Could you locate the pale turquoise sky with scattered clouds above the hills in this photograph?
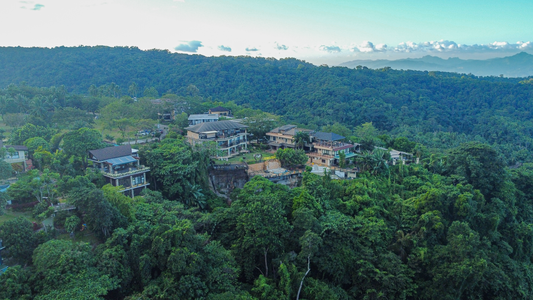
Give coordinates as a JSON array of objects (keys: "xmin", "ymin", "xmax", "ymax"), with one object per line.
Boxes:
[{"xmin": 0, "ymin": 0, "xmax": 533, "ymax": 65}]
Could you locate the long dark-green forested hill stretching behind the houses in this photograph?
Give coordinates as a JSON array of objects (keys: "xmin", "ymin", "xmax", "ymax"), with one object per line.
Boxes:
[{"xmin": 0, "ymin": 47, "xmax": 533, "ymax": 163}]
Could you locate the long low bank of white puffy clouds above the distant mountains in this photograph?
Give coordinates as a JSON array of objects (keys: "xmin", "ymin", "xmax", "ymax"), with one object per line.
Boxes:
[{"xmin": 349, "ymin": 40, "xmax": 533, "ymax": 53}]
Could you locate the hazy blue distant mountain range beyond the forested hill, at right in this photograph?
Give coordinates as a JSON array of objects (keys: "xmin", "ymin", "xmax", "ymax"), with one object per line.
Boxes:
[{"xmin": 340, "ymin": 52, "xmax": 533, "ymax": 77}]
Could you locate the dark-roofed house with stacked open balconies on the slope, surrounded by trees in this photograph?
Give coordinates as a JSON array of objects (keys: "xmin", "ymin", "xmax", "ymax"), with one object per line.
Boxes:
[{"xmin": 89, "ymin": 145, "xmax": 150, "ymax": 197}]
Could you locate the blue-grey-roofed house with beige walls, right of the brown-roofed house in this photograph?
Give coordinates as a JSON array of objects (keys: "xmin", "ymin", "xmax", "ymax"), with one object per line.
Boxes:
[{"xmin": 307, "ymin": 132, "xmax": 360, "ymax": 167}]
